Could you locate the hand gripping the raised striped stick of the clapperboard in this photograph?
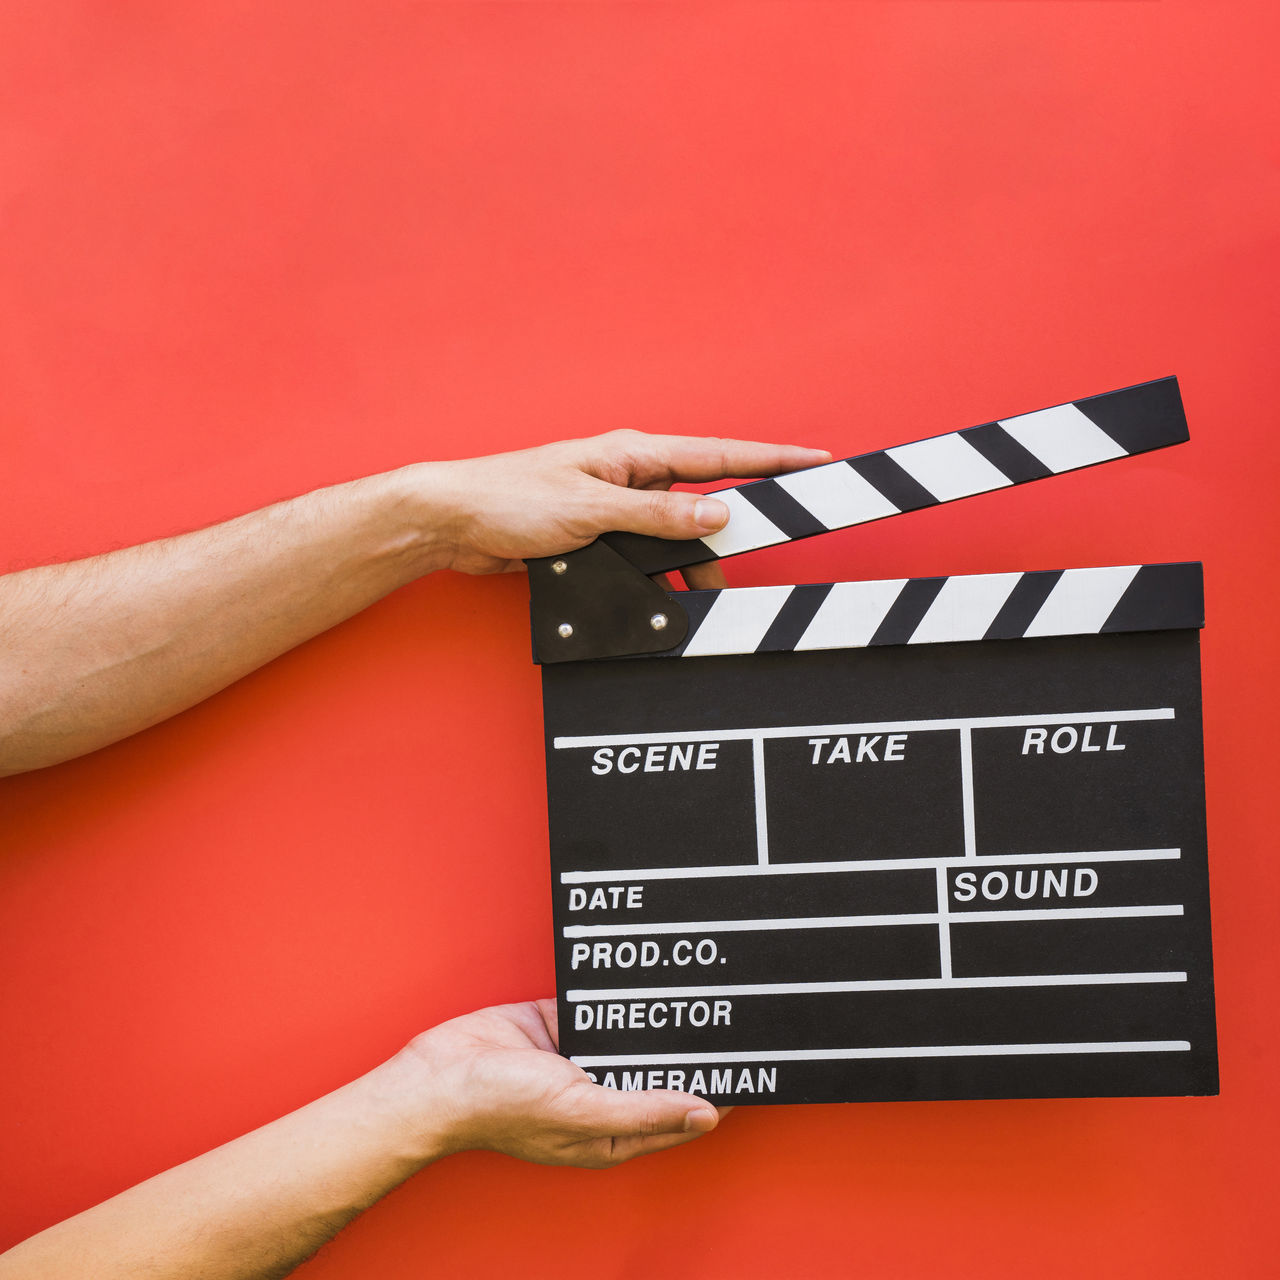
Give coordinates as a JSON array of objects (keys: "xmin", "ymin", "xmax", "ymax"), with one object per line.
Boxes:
[{"xmin": 410, "ymin": 431, "xmax": 831, "ymax": 585}]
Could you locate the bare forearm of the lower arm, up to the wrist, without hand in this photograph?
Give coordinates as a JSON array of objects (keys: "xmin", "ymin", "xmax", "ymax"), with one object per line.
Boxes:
[{"xmin": 0, "ymin": 1057, "xmax": 442, "ymax": 1280}]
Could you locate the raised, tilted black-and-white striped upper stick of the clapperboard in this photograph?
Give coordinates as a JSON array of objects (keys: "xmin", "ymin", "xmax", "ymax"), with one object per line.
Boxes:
[{"xmin": 603, "ymin": 378, "xmax": 1188, "ymax": 573}]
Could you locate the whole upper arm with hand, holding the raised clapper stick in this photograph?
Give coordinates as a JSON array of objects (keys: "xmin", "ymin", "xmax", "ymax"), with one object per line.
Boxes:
[{"xmin": 0, "ymin": 431, "xmax": 828, "ymax": 776}]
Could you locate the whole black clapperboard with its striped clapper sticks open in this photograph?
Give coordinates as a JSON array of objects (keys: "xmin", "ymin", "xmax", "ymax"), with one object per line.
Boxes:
[{"xmin": 530, "ymin": 378, "xmax": 1217, "ymax": 1103}]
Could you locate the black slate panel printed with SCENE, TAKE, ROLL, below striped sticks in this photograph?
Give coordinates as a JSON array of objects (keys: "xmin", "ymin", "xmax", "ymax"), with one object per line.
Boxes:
[{"xmin": 543, "ymin": 628, "xmax": 1217, "ymax": 1105}]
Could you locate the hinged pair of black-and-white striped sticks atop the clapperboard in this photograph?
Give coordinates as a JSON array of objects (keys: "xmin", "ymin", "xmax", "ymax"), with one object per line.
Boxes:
[{"xmin": 529, "ymin": 378, "xmax": 1187, "ymax": 663}]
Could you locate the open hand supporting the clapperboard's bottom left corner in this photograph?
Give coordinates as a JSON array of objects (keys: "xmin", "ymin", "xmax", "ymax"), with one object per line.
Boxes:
[{"xmin": 394, "ymin": 1000, "xmax": 728, "ymax": 1169}]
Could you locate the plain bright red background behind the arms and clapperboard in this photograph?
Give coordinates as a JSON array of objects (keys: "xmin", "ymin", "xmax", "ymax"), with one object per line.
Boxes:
[{"xmin": 0, "ymin": 0, "xmax": 1280, "ymax": 1280}]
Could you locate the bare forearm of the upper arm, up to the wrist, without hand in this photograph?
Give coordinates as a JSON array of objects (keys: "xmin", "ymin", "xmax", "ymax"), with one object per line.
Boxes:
[{"xmin": 0, "ymin": 467, "xmax": 448, "ymax": 774}]
